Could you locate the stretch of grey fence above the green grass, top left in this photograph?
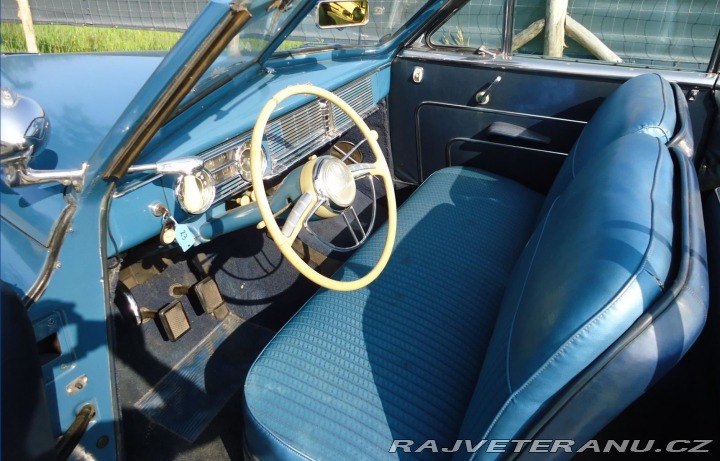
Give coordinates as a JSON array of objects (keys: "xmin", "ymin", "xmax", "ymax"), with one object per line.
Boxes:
[{"xmin": 0, "ymin": 0, "xmax": 207, "ymax": 31}]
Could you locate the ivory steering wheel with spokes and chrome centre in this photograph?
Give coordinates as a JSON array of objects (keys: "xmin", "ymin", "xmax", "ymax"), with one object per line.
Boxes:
[{"xmin": 250, "ymin": 84, "xmax": 397, "ymax": 291}]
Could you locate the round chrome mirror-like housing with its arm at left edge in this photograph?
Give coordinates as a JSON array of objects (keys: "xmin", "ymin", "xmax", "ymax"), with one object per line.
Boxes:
[{"xmin": 0, "ymin": 87, "xmax": 87, "ymax": 190}]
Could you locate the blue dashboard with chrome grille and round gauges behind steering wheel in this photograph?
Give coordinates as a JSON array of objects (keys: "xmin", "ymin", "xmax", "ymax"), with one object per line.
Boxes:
[{"xmin": 108, "ymin": 63, "xmax": 389, "ymax": 254}]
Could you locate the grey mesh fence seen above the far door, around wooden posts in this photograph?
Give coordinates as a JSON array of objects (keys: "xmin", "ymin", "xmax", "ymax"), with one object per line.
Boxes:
[{"xmin": 431, "ymin": 0, "xmax": 720, "ymax": 70}]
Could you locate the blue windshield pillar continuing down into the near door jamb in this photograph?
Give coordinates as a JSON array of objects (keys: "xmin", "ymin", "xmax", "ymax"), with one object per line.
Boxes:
[{"xmin": 11, "ymin": 1, "xmax": 243, "ymax": 460}]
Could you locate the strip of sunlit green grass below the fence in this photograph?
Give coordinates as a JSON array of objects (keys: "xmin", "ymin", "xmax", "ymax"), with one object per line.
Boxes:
[{"xmin": 0, "ymin": 23, "xmax": 182, "ymax": 53}]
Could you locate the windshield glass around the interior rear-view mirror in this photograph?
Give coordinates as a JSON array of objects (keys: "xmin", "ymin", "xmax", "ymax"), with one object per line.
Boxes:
[{"xmin": 277, "ymin": 0, "xmax": 428, "ymax": 52}]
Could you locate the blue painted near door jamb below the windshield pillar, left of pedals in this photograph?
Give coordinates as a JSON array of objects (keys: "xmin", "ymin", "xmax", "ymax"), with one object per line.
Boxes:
[{"xmin": 29, "ymin": 201, "xmax": 118, "ymax": 459}]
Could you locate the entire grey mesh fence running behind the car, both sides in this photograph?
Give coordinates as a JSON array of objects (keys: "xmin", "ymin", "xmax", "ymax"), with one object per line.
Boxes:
[{"xmin": 0, "ymin": 0, "xmax": 720, "ymax": 70}]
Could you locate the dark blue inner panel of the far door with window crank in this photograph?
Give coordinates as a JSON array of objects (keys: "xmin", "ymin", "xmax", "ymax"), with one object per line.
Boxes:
[{"xmin": 389, "ymin": 51, "xmax": 715, "ymax": 186}]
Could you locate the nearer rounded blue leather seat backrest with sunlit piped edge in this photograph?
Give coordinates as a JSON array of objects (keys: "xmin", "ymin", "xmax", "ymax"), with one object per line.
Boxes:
[{"xmin": 456, "ymin": 134, "xmax": 674, "ymax": 459}]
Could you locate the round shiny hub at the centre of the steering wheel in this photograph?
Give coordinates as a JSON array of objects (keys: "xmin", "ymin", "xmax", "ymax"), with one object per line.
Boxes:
[{"xmin": 313, "ymin": 156, "xmax": 357, "ymax": 212}]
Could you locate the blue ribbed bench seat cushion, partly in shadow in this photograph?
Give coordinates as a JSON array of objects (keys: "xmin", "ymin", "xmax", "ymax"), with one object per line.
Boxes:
[{"xmin": 245, "ymin": 168, "xmax": 543, "ymax": 460}]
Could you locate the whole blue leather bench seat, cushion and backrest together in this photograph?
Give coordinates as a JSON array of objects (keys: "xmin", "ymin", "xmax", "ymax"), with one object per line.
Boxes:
[{"xmin": 245, "ymin": 75, "xmax": 707, "ymax": 460}]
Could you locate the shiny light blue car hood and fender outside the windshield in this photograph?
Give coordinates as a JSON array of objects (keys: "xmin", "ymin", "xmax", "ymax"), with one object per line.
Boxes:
[{"xmin": 0, "ymin": 53, "xmax": 164, "ymax": 246}]
